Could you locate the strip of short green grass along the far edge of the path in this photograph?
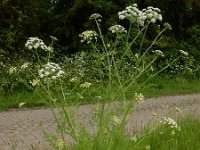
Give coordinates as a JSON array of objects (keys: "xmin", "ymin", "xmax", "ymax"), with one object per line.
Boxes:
[{"xmin": 0, "ymin": 78, "xmax": 200, "ymax": 110}]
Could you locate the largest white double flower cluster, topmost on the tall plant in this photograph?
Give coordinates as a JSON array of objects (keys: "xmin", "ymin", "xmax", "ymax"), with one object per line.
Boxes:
[{"xmin": 118, "ymin": 4, "xmax": 162, "ymax": 26}]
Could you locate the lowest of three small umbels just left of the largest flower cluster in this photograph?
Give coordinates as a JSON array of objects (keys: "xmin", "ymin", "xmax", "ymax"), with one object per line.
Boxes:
[{"xmin": 79, "ymin": 30, "xmax": 98, "ymax": 44}]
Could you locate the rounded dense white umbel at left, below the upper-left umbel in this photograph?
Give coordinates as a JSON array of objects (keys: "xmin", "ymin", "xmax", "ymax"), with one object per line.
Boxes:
[{"xmin": 38, "ymin": 62, "xmax": 64, "ymax": 80}]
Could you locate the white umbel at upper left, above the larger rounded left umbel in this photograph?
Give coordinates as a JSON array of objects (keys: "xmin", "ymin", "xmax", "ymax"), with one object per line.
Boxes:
[{"xmin": 25, "ymin": 37, "xmax": 47, "ymax": 51}]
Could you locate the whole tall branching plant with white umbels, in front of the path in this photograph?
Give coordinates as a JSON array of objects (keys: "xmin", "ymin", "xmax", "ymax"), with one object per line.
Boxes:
[{"xmin": 19, "ymin": 4, "xmax": 191, "ymax": 149}]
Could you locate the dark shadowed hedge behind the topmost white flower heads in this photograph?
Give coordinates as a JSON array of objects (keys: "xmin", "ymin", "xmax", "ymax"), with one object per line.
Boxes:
[{"xmin": 0, "ymin": 0, "xmax": 200, "ymax": 59}]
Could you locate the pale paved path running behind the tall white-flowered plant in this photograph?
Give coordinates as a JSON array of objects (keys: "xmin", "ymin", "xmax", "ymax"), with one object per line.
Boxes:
[{"xmin": 0, "ymin": 94, "xmax": 200, "ymax": 150}]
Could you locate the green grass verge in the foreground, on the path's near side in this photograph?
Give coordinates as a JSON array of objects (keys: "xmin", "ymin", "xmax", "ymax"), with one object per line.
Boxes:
[{"xmin": 48, "ymin": 114, "xmax": 200, "ymax": 150}]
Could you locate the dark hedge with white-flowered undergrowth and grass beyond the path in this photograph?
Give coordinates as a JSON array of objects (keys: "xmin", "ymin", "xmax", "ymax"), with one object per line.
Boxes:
[{"xmin": 0, "ymin": 0, "xmax": 200, "ymax": 108}]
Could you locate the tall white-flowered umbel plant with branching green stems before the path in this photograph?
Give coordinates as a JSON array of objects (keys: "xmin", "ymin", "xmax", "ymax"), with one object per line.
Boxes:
[{"xmin": 21, "ymin": 4, "xmax": 189, "ymax": 150}]
